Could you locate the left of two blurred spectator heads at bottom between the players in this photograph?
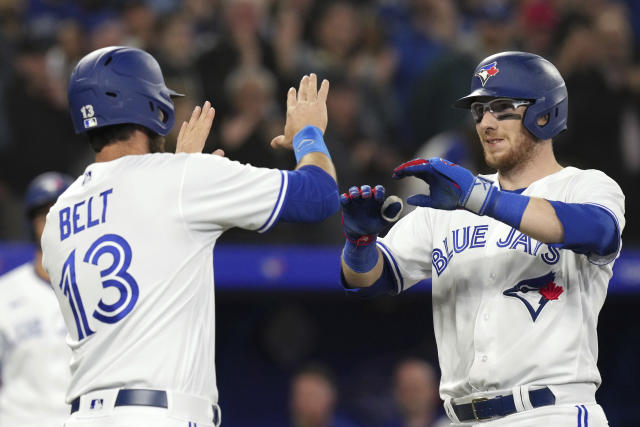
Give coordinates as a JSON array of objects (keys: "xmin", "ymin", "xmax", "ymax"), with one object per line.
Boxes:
[{"xmin": 289, "ymin": 365, "xmax": 355, "ymax": 427}]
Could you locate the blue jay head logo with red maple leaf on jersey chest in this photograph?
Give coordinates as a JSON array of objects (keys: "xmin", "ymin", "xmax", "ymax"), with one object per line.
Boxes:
[{"xmin": 503, "ymin": 271, "xmax": 564, "ymax": 322}]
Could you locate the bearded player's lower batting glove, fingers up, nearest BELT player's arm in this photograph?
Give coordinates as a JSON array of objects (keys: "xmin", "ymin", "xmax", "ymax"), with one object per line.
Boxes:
[{"xmin": 340, "ymin": 185, "xmax": 402, "ymax": 246}]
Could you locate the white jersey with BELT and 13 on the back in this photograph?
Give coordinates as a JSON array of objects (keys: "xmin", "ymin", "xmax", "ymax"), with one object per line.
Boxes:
[{"xmin": 42, "ymin": 153, "xmax": 287, "ymax": 403}]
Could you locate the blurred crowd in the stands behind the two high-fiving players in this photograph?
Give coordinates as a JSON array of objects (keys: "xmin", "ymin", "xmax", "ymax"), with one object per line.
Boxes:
[{"xmin": 0, "ymin": 0, "xmax": 640, "ymax": 244}]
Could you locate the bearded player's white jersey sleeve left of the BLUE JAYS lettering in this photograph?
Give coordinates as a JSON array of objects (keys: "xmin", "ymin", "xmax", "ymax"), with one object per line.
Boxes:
[{"xmin": 377, "ymin": 208, "xmax": 433, "ymax": 294}]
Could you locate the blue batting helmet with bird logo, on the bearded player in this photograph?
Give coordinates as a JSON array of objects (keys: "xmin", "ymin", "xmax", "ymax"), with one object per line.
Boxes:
[{"xmin": 454, "ymin": 52, "xmax": 569, "ymax": 139}]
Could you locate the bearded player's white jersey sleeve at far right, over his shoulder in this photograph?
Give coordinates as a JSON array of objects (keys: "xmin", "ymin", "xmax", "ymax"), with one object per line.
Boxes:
[{"xmin": 565, "ymin": 169, "xmax": 625, "ymax": 265}]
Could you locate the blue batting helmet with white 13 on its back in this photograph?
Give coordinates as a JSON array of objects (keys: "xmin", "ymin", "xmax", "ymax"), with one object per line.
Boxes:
[{"xmin": 68, "ymin": 46, "xmax": 182, "ymax": 135}]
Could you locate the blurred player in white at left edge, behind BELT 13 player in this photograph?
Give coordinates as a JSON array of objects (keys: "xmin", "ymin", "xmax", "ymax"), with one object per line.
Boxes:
[{"xmin": 0, "ymin": 172, "xmax": 72, "ymax": 427}]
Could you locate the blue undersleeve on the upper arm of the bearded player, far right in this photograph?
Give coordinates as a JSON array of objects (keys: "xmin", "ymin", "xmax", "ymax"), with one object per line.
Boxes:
[{"xmin": 549, "ymin": 200, "xmax": 620, "ymax": 255}]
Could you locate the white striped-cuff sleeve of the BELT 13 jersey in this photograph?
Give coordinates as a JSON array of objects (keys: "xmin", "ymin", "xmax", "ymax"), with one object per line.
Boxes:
[{"xmin": 179, "ymin": 154, "xmax": 287, "ymax": 232}]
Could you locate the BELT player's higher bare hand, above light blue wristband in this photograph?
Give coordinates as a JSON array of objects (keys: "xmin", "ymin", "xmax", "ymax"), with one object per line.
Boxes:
[{"xmin": 271, "ymin": 73, "xmax": 329, "ymax": 150}]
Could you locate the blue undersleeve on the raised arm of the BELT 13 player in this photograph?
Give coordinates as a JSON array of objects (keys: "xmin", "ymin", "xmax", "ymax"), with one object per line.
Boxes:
[{"xmin": 279, "ymin": 165, "xmax": 340, "ymax": 222}]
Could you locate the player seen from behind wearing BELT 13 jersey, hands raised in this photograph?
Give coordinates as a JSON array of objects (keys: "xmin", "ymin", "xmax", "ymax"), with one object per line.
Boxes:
[{"xmin": 42, "ymin": 47, "xmax": 339, "ymax": 427}]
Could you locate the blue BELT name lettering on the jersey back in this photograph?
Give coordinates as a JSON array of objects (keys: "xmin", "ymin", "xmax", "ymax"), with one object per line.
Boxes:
[{"xmin": 59, "ymin": 188, "xmax": 113, "ymax": 241}]
